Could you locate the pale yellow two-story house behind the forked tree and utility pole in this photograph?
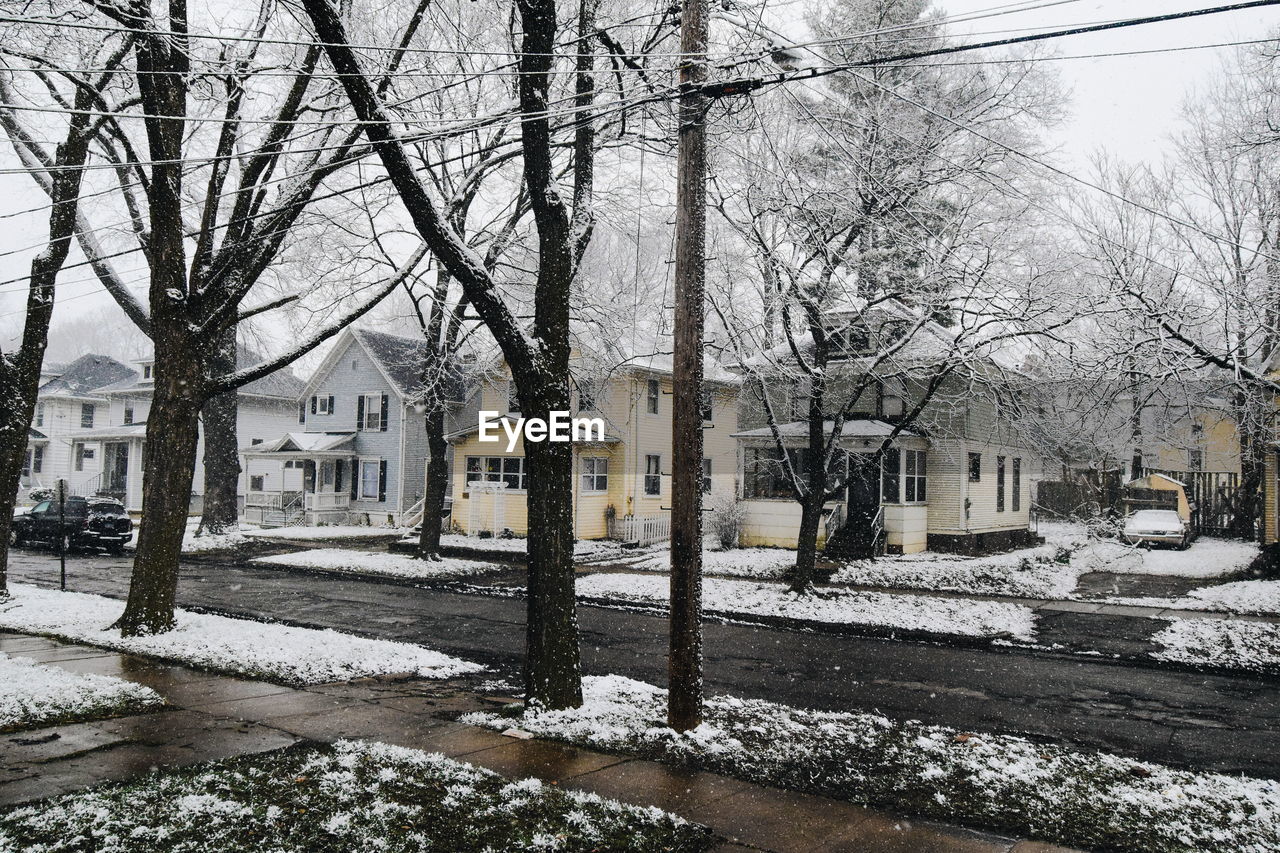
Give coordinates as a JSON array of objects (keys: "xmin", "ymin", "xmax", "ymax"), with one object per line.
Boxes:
[{"xmin": 449, "ymin": 356, "xmax": 739, "ymax": 543}]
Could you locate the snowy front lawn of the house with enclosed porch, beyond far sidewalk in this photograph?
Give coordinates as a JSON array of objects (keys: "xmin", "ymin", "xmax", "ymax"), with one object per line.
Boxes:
[{"xmin": 831, "ymin": 544, "xmax": 1080, "ymax": 598}]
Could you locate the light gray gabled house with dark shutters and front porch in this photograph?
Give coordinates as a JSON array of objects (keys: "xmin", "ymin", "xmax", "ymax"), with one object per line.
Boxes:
[{"xmin": 241, "ymin": 329, "xmax": 460, "ymax": 526}]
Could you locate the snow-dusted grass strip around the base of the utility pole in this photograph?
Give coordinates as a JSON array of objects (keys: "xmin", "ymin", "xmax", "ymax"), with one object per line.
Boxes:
[{"xmin": 462, "ymin": 676, "xmax": 1280, "ymax": 853}]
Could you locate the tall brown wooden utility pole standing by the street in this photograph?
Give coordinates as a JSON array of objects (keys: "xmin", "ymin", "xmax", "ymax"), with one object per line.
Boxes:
[{"xmin": 667, "ymin": 0, "xmax": 708, "ymax": 731}]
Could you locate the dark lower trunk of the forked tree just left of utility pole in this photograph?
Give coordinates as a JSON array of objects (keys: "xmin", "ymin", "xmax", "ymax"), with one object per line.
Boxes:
[{"xmin": 525, "ymin": 394, "xmax": 582, "ymax": 710}]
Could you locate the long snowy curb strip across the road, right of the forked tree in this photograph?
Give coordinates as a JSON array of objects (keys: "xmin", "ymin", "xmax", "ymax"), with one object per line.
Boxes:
[{"xmin": 577, "ymin": 574, "xmax": 1036, "ymax": 640}]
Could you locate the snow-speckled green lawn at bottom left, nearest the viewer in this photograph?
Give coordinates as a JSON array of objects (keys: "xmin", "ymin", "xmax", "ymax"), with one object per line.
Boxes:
[{"xmin": 0, "ymin": 740, "xmax": 710, "ymax": 853}]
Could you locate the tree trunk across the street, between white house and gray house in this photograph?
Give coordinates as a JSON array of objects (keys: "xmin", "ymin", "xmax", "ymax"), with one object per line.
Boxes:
[{"xmin": 200, "ymin": 325, "xmax": 241, "ymax": 535}]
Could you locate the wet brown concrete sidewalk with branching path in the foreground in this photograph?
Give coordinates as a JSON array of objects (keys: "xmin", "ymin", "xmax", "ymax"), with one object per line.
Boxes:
[{"xmin": 0, "ymin": 633, "xmax": 1080, "ymax": 853}]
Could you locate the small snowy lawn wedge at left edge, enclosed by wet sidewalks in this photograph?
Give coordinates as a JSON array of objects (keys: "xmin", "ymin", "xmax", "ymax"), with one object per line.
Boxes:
[{"xmin": 0, "ymin": 653, "xmax": 163, "ymax": 731}]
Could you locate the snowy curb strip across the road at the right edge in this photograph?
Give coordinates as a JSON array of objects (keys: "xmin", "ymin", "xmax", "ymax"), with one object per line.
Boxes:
[{"xmin": 1151, "ymin": 619, "xmax": 1280, "ymax": 672}]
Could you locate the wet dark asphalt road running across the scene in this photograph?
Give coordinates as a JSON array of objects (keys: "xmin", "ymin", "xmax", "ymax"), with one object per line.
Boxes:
[{"xmin": 10, "ymin": 549, "xmax": 1280, "ymax": 779}]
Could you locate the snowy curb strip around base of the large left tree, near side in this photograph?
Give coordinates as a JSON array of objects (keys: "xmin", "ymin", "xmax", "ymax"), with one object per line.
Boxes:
[{"xmin": 0, "ymin": 584, "xmax": 484, "ymax": 684}]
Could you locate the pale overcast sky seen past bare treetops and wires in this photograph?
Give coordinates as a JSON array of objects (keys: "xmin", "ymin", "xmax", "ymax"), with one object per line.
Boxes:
[{"xmin": 0, "ymin": 0, "xmax": 1280, "ymax": 342}]
